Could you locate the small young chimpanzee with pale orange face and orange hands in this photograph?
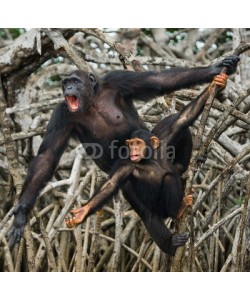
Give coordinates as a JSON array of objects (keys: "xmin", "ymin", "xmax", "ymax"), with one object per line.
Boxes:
[{"xmin": 66, "ymin": 74, "xmax": 228, "ymax": 255}]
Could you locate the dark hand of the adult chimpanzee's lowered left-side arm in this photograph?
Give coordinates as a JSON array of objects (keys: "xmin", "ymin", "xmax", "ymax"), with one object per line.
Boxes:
[{"xmin": 7, "ymin": 204, "xmax": 28, "ymax": 248}]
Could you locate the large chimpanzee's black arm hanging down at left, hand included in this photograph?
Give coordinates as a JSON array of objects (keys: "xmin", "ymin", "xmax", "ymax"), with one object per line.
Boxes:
[{"xmin": 8, "ymin": 105, "xmax": 71, "ymax": 247}]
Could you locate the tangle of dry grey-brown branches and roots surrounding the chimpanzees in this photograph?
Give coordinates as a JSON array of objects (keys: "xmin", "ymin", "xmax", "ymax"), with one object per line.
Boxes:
[{"xmin": 0, "ymin": 29, "xmax": 250, "ymax": 272}]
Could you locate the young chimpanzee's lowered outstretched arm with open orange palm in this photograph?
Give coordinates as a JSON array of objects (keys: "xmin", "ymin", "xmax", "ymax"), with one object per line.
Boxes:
[{"xmin": 65, "ymin": 164, "xmax": 133, "ymax": 228}]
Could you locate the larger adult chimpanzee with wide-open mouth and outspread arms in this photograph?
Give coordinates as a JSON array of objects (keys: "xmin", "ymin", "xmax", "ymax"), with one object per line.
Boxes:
[{"xmin": 9, "ymin": 56, "xmax": 239, "ymax": 246}]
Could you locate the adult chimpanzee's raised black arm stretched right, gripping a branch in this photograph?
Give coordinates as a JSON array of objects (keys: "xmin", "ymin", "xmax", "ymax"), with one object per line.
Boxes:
[{"xmin": 103, "ymin": 56, "xmax": 239, "ymax": 100}]
